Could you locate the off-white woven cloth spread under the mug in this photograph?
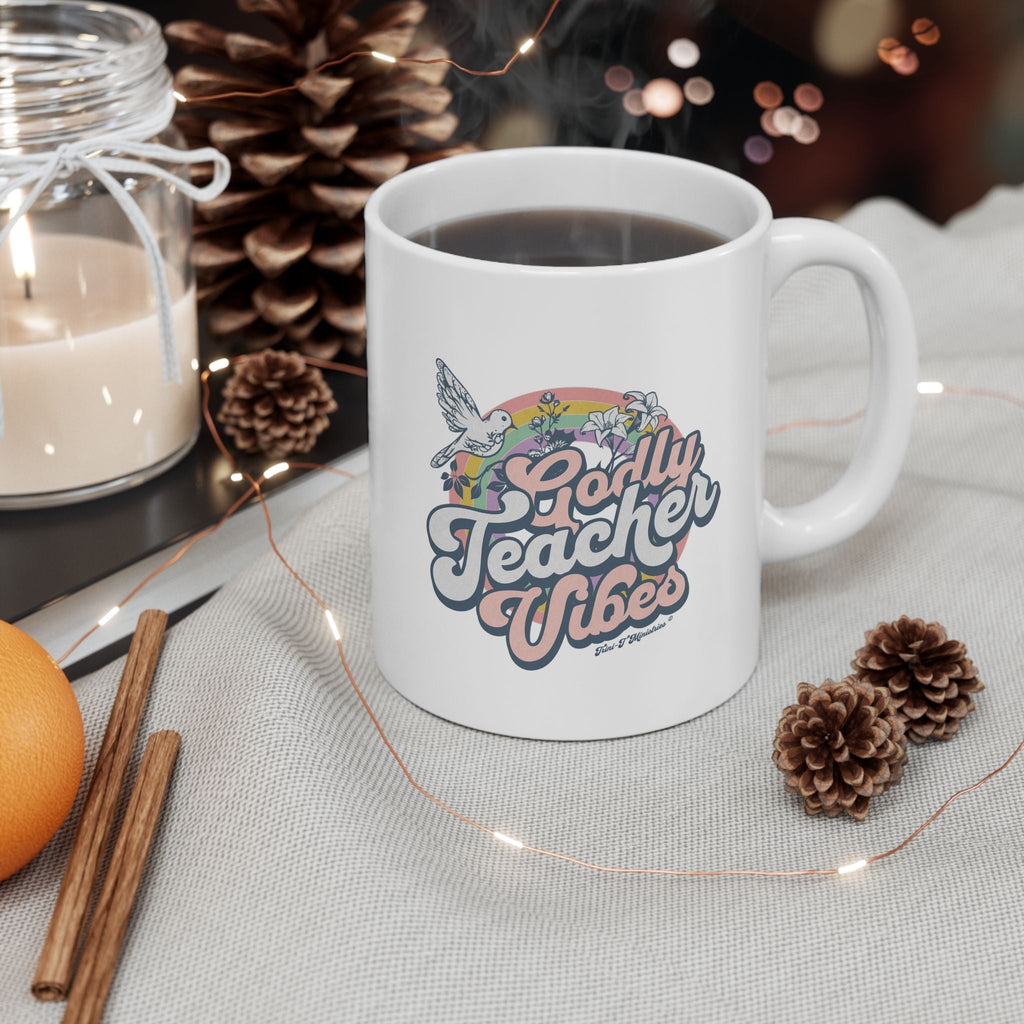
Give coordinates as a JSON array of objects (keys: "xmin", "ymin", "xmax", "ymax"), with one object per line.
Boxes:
[{"xmin": 0, "ymin": 189, "xmax": 1024, "ymax": 1024}]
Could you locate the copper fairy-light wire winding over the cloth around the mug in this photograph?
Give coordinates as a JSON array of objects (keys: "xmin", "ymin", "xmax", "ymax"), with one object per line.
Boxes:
[{"xmin": 57, "ymin": 356, "xmax": 1024, "ymax": 879}]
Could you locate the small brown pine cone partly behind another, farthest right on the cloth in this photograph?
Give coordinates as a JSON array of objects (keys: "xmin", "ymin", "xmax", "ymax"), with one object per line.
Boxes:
[{"xmin": 852, "ymin": 615, "xmax": 985, "ymax": 743}]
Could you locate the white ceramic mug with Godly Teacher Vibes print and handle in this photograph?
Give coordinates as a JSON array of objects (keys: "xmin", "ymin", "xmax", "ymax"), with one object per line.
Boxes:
[{"xmin": 366, "ymin": 147, "xmax": 916, "ymax": 739}]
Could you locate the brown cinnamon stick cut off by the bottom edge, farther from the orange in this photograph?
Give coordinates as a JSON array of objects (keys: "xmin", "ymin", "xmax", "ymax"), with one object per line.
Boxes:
[{"xmin": 63, "ymin": 732, "xmax": 181, "ymax": 1024}]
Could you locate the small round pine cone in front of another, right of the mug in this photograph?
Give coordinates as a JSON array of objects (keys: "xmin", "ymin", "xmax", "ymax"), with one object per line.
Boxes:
[{"xmin": 772, "ymin": 676, "xmax": 906, "ymax": 821}]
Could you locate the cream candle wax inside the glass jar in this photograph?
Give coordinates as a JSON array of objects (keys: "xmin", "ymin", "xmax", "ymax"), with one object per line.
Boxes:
[{"xmin": 0, "ymin": 234, "xmax": 199, "ymax": 499}]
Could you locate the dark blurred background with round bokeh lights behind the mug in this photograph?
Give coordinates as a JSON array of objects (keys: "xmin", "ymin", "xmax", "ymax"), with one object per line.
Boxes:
[{"xmin": 146, "ymin": 0, "xmax": 1024, "ymax": 221}]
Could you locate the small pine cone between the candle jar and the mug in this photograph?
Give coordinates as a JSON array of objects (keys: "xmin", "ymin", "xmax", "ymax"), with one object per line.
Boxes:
[{"xmin": 217, "ymin": 349, "xmax": 338, "ymax": 458}]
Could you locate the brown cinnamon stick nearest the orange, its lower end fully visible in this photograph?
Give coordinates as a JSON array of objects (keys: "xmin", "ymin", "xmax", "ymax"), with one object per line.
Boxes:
[{"xmin": 32, "ymin": 610, "xmax": 167, "ymax": 1002}]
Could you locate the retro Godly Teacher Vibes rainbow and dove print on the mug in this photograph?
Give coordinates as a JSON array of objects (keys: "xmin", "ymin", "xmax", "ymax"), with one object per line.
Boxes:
[{"xmin": 426, "ymin": 359, "xmax": 721, "ymax": 669}]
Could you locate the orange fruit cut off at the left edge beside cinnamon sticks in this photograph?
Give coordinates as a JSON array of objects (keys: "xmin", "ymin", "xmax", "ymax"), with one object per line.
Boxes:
[{"xmin": 0, "ymin": 622, "xmax": 85, "ymax": 880}]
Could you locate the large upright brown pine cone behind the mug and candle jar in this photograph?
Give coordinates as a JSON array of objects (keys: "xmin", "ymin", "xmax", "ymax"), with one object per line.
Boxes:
[{"xmin": 166, "ymin": 0, "xmax": 474, "ymax": 358}]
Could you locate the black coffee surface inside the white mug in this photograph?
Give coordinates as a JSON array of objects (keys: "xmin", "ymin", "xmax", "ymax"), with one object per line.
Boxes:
[{"xmin": 411, "ymin": 209, "xmax": 726, "ymax": 266}]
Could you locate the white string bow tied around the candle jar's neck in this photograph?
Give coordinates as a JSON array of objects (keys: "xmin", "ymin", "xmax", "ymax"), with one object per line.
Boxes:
[{"xmin": 0, "ymin": 135, "xmax": 231, "ymax": 437}]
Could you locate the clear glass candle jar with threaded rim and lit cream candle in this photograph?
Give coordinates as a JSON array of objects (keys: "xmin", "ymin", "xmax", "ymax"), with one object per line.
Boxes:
[{"xmin": 0, "ymin": 0, "xmax": 226, "ymax": 508}]
